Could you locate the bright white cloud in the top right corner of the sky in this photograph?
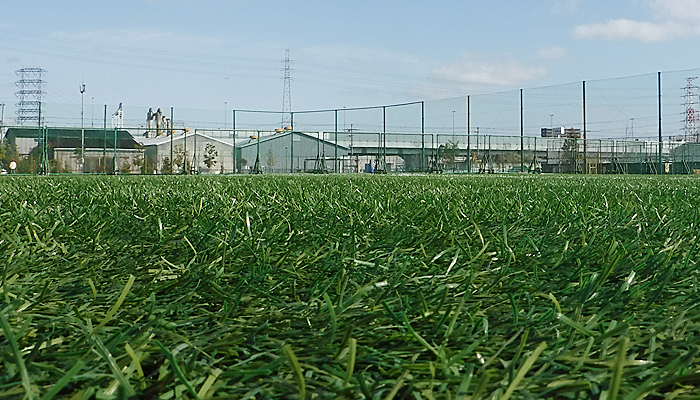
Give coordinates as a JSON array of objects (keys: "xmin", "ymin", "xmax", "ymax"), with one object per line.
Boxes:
[{"xmin": 574, "ymin": 0, "xmax": 700, "ymax": 42}]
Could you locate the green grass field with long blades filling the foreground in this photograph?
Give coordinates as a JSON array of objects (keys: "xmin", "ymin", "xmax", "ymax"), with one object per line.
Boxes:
[{"xmin": 0, "ymin": 176, "xmax": 700, "ymax": 399}]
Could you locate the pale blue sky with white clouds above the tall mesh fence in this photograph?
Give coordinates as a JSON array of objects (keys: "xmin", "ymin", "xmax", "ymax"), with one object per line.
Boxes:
[{"xmin": 0, "ymin": 0, "xmax": 700, "ymax": 136}]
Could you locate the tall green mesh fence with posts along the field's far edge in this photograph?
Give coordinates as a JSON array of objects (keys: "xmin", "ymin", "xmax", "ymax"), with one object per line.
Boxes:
[{"xmin": 0, "ymin": 69, "xmax": 700, "ymax": 174}]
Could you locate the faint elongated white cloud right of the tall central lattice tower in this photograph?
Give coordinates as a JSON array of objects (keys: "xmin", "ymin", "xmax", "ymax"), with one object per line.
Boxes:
[{"xmin": 433, "ymin": 55, "xmax": 547, "ymax": 86}]
